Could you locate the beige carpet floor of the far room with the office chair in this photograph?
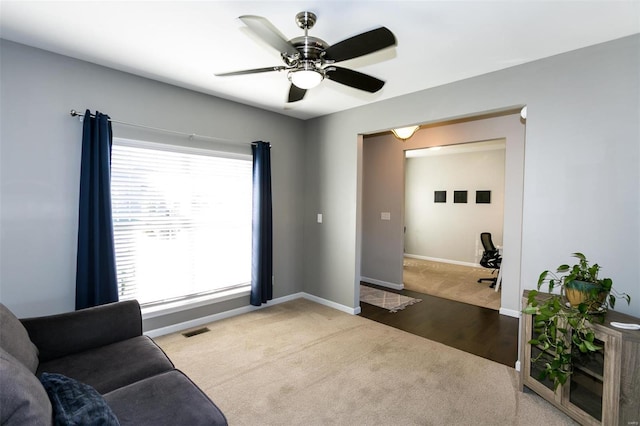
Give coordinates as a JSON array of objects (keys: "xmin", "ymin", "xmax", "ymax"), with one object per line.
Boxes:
[{"xmin": 403, "ymin": 257, "xmax": 500, "ymax": 310}]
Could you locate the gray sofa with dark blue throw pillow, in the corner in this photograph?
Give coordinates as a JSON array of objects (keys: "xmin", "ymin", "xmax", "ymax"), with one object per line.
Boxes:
[{"xmin": 0, "ymin": 301, "xmax": 227, "ymax": 426}]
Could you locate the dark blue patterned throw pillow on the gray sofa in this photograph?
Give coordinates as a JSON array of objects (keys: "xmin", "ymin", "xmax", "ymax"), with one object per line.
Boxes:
[{"xmin": 40, "ymin": 373, "xmax": 120, "ymax": 426}]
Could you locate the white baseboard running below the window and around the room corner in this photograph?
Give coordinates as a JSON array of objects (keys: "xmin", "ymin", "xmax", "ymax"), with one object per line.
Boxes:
[{"xmin": 144, "ymin": 292, "xmax": 360, "ymax": 338}]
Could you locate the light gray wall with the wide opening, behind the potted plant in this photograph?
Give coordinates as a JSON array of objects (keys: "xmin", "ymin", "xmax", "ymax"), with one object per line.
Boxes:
[{"xmin": 304, "ymin": 35, "xmax": 640, "ymax": 316}]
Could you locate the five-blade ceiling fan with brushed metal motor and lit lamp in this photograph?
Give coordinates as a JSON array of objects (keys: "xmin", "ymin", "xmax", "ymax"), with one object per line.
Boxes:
[{"xmin": 216, "ymin": 12, "xmax": 396, "ymax": 102}]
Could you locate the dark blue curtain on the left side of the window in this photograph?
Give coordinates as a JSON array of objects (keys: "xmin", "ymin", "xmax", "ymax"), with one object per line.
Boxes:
[{"xmin": 76, "ymin": 110, "xmax": 118, "ymax": 309}]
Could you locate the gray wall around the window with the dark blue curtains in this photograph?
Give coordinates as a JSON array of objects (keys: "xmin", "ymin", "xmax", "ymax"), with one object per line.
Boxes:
[{"xmin": 0, "ymin": 40, "xmax": 304, "ymax": 327}]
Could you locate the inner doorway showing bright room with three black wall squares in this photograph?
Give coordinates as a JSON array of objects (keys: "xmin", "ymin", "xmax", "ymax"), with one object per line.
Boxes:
[{"xmin": 403, "ymin": 139, "xmax": 506, "ymax": 310}]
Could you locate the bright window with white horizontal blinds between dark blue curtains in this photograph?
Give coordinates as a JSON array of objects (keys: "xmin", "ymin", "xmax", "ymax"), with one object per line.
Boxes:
[{"xmin": 111, "ymin": 138, "xmax": 252, "ymax": 304}]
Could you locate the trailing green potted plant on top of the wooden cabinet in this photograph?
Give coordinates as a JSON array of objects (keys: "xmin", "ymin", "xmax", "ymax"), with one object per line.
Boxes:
[{"xmin": 523, "ymin": 253, "xmax": 631, "ymax": 390}]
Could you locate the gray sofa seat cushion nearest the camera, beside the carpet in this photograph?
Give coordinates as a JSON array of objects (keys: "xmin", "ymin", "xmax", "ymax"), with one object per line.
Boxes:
[{"xmin": 104, "ymin": 370, "xmax": 227, "ymax": 426}]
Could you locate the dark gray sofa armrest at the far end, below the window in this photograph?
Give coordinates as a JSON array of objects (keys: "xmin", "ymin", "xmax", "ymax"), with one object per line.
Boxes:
[{"xmin": 20, "ymin": 300, "xmax": 142, "ymax": 362}]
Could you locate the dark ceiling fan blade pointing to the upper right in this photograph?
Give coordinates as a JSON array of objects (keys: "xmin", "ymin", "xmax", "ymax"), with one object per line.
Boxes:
[{"xmin": 324, "ymin": 27, "xmax": 396, "ymax": 62}]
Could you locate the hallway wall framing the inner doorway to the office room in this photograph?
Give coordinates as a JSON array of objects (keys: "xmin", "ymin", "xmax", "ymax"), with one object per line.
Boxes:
[{"xmin": 360, "ymin": 108, "xmax": 525, "ymax": 364}]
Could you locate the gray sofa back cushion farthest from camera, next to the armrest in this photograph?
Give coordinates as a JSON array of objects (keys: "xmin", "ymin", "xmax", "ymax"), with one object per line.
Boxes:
[{"xmin": 0, "ymin": 303, "xmax": 38, "ymax": 373}]
